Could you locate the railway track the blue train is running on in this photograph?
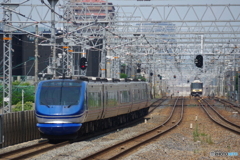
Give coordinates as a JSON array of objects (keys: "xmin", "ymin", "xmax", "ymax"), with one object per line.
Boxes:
[{"xmin": 0, "ymin": 98, "xmax": 167, "ymax": 160}]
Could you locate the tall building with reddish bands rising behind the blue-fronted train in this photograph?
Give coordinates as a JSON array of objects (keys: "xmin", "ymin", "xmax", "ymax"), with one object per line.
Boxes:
[{"xmin": 65, "ymin": 0, "xmax": 115, "ymax": 77}]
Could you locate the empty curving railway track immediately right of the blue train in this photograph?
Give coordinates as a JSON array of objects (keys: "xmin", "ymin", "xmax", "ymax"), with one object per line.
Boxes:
[{"xmin": 83, "ymin": 98, "xmax": 184, "ymax": 160}]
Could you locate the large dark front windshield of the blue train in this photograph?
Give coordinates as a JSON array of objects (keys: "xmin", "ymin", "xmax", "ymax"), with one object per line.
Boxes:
[{"xmin": 40, "ymin": 81, "xmax": 81, "ymax": 106}]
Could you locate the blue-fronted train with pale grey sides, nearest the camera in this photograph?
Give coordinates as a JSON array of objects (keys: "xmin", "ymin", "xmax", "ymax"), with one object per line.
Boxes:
[{"xmin": 35, "ymin": 77, "xmax": 154, "ymax": 140}]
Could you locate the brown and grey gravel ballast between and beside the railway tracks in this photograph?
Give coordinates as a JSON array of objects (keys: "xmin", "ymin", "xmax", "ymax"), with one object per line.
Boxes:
[{"xmin": 1, "ymin": 100, "xmax": 240, "ymax": 160}]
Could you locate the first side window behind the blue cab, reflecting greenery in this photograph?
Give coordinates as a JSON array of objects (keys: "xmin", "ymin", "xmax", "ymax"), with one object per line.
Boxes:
[{"xmin": 88, "ymin": 92, "xmax": 101, "ymax": 108}]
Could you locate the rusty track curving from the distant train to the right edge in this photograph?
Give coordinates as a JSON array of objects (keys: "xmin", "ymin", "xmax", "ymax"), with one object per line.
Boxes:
[{"xmin": 198, "ymin": 99, "xmax": 240, "ymax": 134}]
